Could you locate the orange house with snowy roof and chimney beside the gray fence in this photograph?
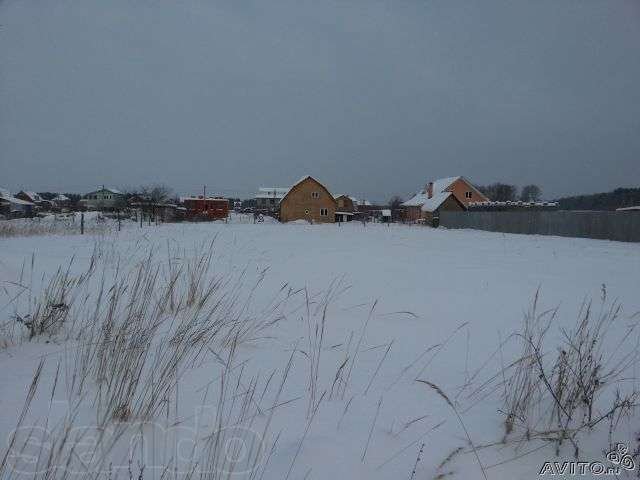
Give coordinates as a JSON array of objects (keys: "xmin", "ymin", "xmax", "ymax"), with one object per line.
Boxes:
[{"xmin": 401, "ymin": 177, "xmax": 489, "ymax": 222}]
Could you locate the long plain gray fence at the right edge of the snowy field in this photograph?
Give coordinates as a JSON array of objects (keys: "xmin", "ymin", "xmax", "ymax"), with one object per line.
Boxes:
[{"xmin": 440, "ymin": 210, "xmax": 640, "ymax": 242}]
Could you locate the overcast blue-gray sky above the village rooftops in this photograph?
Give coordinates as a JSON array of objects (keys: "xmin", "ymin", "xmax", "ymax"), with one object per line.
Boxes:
[{"xmin": 0, "ymin": 0, "xmax": 640, "ymax": 200}]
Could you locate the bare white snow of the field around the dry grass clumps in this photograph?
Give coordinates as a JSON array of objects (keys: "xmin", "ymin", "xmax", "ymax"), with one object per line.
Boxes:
[{"xmin": 0, "ymin": 219, "xmax": 640, "ymax": 479}]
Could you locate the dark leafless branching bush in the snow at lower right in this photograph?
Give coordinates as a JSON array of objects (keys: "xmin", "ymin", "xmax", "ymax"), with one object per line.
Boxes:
[{"xmin": 503, "ymin": 287, "xmax": 639, "ymax": 457}]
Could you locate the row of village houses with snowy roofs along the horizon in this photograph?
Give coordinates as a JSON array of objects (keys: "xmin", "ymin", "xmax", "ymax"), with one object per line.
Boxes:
[{"xmin": 0, "ymin": 175, "xmax": 489, "ymax": 224}]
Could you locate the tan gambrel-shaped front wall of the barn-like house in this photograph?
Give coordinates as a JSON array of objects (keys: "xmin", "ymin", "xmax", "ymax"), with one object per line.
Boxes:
[{"xmin": 280, "ymin": 178, "xmax": 336, "ymax": 223}]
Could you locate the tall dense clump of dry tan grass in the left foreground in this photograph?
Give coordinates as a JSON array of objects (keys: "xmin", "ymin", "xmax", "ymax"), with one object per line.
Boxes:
[{"xmin": 66, "ymin": 246, "xmax": 288, "ymax": 423}]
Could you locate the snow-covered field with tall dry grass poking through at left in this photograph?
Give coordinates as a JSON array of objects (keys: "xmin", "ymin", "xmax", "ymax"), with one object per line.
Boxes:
[{"xmin": 0, "ymin": 222, "xmax": 640, "ymax": 479}]
